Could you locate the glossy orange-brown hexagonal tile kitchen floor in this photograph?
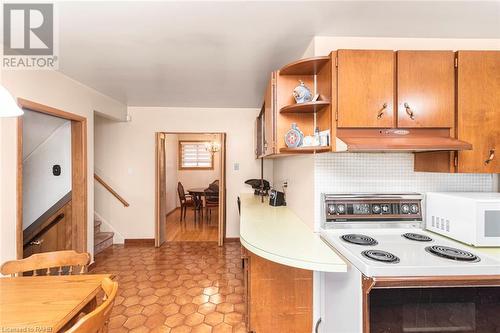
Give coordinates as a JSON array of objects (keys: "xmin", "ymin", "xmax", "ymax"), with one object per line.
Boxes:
[{"xmin": 92, "ymin": 242, "xmax": 245, "ymax": 333}]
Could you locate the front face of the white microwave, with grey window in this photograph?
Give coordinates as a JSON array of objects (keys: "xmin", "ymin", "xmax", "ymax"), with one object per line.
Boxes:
[{"xmin": 474, "ymin": 202, "xmax": 500, "ymax": 246}]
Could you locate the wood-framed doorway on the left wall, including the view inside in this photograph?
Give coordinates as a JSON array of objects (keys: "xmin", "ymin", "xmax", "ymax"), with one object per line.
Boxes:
[{"xmin": 16, "ymin": 98, "xmax": 87, "ymax": 259}]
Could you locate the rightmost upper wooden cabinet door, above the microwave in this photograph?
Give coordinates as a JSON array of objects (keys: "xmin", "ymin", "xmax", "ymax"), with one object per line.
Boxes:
[{"xmin": 457, "ymin": 51, "xmax": 500, "ymax": 173}]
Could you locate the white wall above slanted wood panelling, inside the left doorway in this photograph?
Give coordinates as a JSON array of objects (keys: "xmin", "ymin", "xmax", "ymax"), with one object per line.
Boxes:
[{"xmin": 23, "ymin": 121, "xmax": 71, "ymax": 229}]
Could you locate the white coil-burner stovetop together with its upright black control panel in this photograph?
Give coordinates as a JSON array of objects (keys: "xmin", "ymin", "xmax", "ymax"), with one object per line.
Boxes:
[{"xmin": 320, "ymin": 194, "xmax": 500, "ymax": 277}]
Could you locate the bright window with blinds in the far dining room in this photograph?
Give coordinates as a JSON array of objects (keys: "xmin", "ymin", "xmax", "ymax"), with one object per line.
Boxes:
[{"xmin": 179, "ymin": 141, "xmax": 214, "ymax": 170}]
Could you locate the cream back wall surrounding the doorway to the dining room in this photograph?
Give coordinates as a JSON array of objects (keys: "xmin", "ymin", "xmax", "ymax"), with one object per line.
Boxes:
[{"xmin": 95, "ymin": 107, "xmax": 272, "ymax": 238}]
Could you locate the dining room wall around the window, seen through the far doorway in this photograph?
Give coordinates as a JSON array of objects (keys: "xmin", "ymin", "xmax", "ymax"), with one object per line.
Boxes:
[{"xmin": 176, "ymin": 134, "xmax": 221, "ymax": 206}]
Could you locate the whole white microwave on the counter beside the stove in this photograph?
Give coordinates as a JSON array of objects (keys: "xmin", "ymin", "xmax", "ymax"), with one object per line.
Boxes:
[{"xmin": 425, "ymin": 192, "xmax": 500, "ymax": 247}]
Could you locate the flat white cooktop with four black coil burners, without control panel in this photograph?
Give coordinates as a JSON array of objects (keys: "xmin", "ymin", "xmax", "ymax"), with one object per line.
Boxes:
[{"xmin": 321, "ymin": 228, "xmax": 500, "ymax": 277}]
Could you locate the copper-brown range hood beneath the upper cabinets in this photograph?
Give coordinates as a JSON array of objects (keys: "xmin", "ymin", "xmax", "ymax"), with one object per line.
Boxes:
[{"xmin": 336, "ymin": 128, "xmax": 472, "ymax": 152}]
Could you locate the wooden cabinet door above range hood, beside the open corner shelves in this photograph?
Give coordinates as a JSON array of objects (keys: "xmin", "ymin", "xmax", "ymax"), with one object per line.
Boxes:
[{"xmin": 337, "ymin": 50, "xmax": 395, "ymax": 127}]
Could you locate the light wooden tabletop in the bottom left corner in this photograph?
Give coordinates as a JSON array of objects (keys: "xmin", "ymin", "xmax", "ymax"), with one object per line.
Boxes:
[{"xmin": 0, "ymin": 274, "xmax": 112, "ymax": 333}]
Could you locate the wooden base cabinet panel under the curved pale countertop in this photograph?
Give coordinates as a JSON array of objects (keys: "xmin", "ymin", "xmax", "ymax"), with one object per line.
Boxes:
[{"xmin": 245, "ymin": 251, "xmax": 313, "ymax": 333}]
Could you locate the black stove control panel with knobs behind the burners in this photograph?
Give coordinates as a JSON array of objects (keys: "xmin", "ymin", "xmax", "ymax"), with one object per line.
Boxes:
[{"xmin": 324, "ymin": 194, "xmax": 422, "ymax": 222}]
